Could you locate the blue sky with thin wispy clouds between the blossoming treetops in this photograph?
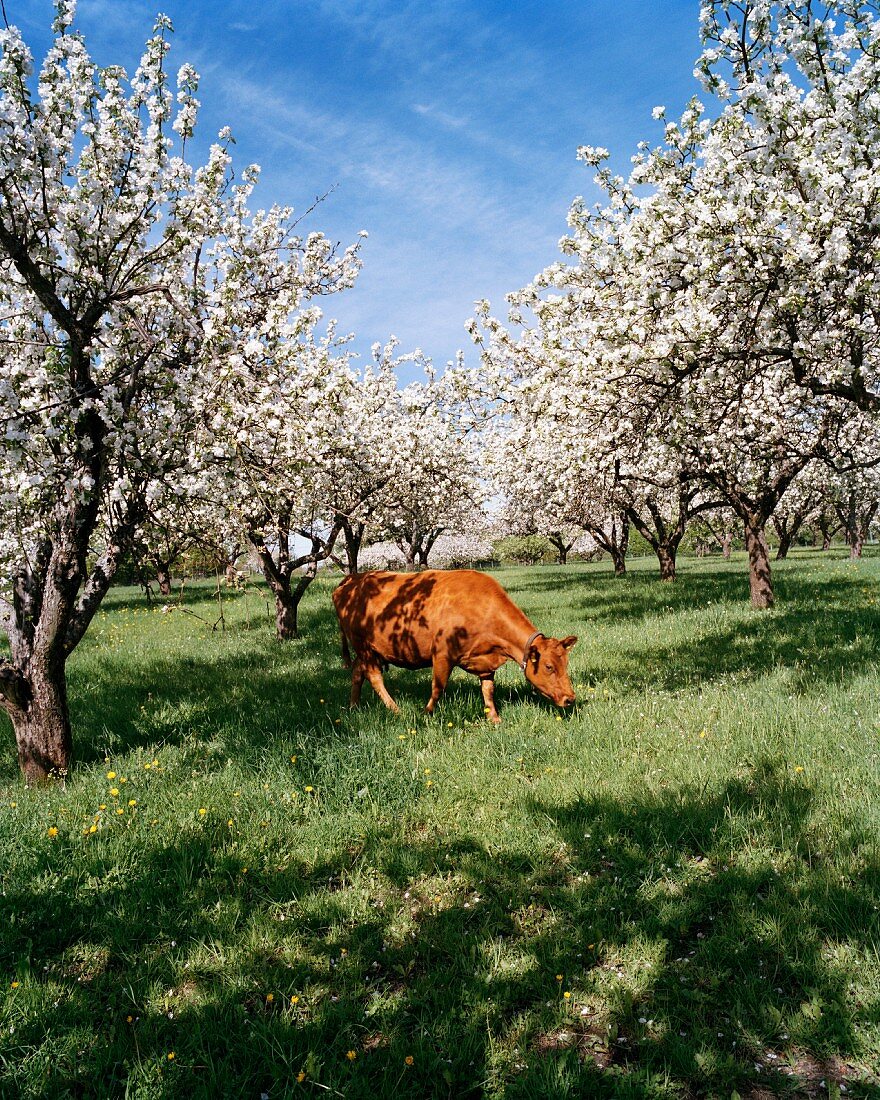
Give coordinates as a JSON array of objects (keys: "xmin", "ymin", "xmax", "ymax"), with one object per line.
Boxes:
[{"xmin": 13, "ymin": 0, "xmax": 700, "ymax": 365}]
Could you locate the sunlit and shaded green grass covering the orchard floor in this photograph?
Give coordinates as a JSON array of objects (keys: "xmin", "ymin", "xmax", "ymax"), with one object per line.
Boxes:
[{"xmin": 0, "ymin": 552, "xmax": 880, "ymax": 1100}]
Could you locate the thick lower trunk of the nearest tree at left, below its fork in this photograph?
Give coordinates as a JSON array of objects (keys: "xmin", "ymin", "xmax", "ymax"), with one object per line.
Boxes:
[{"xmin": 7, "ymin": 659, "xmax": 73, "ymax": 785}]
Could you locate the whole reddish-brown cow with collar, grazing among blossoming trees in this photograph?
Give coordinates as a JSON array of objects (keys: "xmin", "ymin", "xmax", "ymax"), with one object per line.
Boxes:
[{"xmin": 333, "ymin": 569, "xmax": 578, "ymax": 723}]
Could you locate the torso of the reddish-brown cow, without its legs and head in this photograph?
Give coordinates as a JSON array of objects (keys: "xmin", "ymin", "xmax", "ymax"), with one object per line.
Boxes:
[{"xmin": 333, "ymin": 569, "xmax": 528, "ymax": 668}]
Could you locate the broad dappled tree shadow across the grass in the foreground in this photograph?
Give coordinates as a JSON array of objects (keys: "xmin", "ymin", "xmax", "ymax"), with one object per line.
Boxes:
[{"xmin": 0, "ymin": 760, "xmax": 880, "ymax": 1100}]
